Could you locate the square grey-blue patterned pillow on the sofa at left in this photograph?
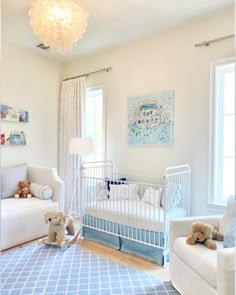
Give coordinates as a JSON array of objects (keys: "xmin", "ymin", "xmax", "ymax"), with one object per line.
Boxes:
[{"xmin": 0, "ymin": 164, "xmax": 27, "ymax": 199}]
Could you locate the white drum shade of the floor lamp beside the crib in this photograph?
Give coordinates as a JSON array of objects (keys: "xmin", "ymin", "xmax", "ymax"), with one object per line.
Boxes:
[{"xmin": 69, "ymin": 137, "xmax": 93, "ymax": 155}]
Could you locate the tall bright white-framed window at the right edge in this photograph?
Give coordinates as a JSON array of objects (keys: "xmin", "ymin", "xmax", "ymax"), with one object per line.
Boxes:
[{"xmin": 209, "ymin": 59, "xmax": 235, "ymax": 205}]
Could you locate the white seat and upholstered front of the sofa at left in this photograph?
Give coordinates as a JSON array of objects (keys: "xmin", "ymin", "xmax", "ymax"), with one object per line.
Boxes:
[{"xmin": 0, "ymin": 197, "xmax": 59, "ymax": 250}]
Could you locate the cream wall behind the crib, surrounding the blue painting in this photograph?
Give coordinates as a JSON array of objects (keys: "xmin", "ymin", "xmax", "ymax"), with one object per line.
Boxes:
[{"xmin": 63, "ymin": 10, "xmax": 234, "ymax": 215}]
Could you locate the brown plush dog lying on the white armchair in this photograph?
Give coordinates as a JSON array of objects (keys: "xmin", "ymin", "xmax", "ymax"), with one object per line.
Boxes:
[{"xmin": 186, "ymin": 222, "xmax": 224, "ymax": 250}]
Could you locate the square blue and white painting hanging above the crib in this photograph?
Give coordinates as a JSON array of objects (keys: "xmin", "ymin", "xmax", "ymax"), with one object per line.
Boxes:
[{"xmin": 128, "ymin": 90, "xmax": 174, "ymax": 145}]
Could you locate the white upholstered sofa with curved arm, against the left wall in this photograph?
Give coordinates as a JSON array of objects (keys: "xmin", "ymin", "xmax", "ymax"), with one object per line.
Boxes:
[{"xmin": 0, "ymin": 164, "xmax": 64, "ymax": 250}]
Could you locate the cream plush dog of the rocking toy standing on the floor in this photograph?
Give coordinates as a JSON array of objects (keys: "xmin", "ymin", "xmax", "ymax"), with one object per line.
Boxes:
[{"xmin": 44, "ymin": 210, "xmax": 75, "ymax": 244}]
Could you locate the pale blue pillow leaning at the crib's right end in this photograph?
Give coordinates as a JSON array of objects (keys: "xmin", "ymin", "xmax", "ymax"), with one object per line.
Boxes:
[{"xmin": 161, "ymin": 182, "xmax": 182, "ymax": 211}]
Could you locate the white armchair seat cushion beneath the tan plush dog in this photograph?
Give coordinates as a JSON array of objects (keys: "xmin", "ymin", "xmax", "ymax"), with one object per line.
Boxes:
[{"xmin": 174, "ymin": 237, "xmax": 224, "ymax": 288}]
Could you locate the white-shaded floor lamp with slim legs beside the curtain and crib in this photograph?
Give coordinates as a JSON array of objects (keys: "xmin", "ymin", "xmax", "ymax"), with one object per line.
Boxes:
[{"xmin": 69, "ymin": 137, "xmax": 93, "ymax": 215}]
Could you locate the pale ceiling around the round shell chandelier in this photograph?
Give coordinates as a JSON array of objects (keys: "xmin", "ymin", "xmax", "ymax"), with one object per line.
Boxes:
[{"xmin": 1, "ymin": 0, "xmax": 234, "ymax": 62}]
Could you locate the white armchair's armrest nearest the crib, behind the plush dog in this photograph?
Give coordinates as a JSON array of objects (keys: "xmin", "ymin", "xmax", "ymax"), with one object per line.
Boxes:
[{"xmin": 170, "ymin": 215, "xmax": 223, "ymax": 252}]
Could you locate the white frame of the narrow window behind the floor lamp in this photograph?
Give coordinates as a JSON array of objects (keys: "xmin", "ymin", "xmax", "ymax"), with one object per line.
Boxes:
[{"xmin": 81, "ymin": 85, "xmax": 107, "ymax": 162}]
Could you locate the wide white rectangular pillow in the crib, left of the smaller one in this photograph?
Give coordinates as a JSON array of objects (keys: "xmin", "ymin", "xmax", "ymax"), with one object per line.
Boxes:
[{"xmin": 109, "ymin": 183, "xmax": 139, "ymax": 200}]
